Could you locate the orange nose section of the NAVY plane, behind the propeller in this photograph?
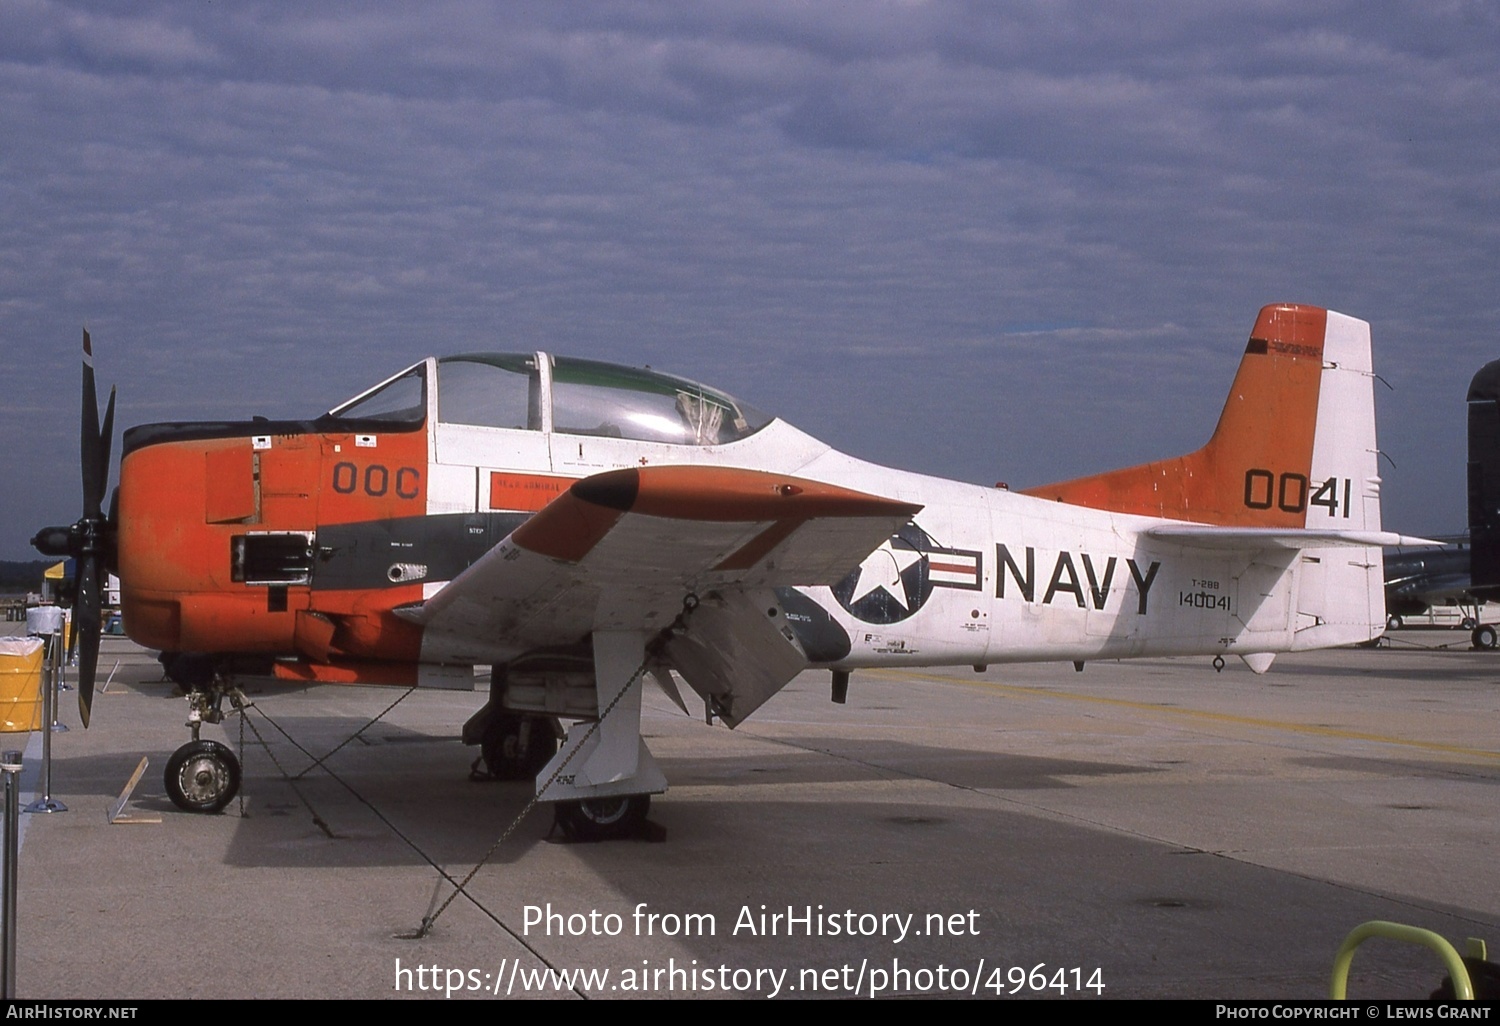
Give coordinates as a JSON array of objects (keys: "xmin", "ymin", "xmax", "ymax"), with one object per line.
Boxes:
[{"xmin": 119, "ymin": 423, "xmax": 428, "ymax": 662}]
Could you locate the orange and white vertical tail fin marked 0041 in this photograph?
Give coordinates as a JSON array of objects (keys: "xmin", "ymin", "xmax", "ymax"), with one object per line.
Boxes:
[{"xmin": 1026, "ymin": 305, "xmax": 1380, "ymax": 537}]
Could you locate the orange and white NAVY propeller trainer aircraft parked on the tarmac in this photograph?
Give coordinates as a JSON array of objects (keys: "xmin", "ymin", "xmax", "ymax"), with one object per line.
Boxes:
[{"xmin": 35, "ymin": 305, "xmax": 1412, "ymax": 837}]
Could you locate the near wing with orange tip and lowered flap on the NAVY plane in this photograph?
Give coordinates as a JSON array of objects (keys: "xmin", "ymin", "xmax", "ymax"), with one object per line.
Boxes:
[{"xmin": 401, "ymin": 467, "xmax": 921, "ymax": 726}]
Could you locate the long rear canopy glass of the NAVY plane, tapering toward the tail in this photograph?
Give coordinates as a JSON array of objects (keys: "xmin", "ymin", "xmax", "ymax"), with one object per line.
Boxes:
[{"xmin": 552, "ymin": 357, "xmax": 771, "ymax": 446}]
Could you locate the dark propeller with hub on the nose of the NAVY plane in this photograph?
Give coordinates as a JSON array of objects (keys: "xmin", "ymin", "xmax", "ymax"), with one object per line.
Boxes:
[{"xmin": 32, "ymin": 330, "xmax": 116, "ymax": 728}]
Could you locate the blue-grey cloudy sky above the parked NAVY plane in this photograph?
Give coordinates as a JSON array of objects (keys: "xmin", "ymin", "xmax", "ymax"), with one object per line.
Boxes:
[{"xmin": 0, "ymin": 0, "xmax": 1500, "ymax": 558}]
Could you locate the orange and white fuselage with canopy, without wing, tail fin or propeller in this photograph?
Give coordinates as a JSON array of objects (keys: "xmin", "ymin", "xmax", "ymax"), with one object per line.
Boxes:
[{"xmin": 119, "ymin": 346, "xmax": 1383, "ymax": 683}]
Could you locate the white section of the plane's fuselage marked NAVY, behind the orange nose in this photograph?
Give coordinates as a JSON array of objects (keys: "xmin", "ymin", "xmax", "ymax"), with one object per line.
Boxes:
[{"xmin": 423, "ymin": 420, "xmax": 1385, "ymax": 669}]
